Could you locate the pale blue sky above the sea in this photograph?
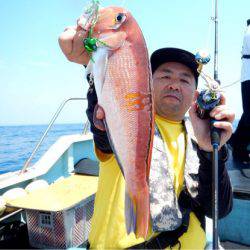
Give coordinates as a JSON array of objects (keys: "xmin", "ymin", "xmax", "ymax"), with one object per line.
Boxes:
[{"xmin": 0, "ymin": 0, "xmax": 250, "ymax": 125}]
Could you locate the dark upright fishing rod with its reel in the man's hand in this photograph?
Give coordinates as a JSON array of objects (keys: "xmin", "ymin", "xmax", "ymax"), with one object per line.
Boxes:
[{"xmin": 195, "ymin": 0, "xmax": 221, "ymax": 250}]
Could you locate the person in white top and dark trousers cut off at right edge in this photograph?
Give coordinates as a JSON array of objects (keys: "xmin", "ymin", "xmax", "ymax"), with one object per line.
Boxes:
[{"xmin": 230, "ymin": 19, "xmax": 250, "ymax": 164}]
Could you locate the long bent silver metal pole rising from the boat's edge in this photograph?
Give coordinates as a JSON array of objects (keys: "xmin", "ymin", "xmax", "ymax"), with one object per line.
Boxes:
[{"xmin": 20, "ymin": 97, "xmax": 86, "ymax": 174}]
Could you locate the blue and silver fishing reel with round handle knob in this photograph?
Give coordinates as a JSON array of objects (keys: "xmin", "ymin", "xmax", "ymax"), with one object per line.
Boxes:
[{"xmin": 195, "ymin": 51, "xmax": 221, "ymax": 119}]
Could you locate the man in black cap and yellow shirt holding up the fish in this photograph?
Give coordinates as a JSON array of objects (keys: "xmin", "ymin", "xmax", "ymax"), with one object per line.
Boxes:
[{"xmin": 59, "ymin": 25, "xmax": 234, "ymax": 249}]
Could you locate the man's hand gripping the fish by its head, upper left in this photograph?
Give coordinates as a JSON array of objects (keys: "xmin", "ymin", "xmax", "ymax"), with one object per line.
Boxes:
[{"xmin": 58, "ymin": 19, "xmax": 90, "ymax": 65}]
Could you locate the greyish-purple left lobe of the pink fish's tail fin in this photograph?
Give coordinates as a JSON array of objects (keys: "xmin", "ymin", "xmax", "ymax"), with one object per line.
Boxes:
[{"xmin": 125, "ymin": 190, "xmax": 136, "ymax": 235}]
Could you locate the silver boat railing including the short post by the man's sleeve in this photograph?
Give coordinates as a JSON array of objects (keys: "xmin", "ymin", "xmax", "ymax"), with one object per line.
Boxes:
[{"xmin": 20, "ymin": 97, "xmax": 89, "ymax": 174}]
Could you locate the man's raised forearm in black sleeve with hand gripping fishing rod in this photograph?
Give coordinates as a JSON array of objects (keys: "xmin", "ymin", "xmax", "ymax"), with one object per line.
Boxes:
[{"xmin": 189, "ymin": 92, "xmax": 234, "ymax": 218}]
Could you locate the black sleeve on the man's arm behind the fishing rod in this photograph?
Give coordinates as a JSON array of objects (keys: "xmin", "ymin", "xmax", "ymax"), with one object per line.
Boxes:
[{"xmin": 191, "ymin": 146, "xmax": 233, "ymax": 218}]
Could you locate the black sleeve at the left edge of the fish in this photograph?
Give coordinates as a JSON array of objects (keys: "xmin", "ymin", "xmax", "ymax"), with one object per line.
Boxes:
[{"xmin": 86, "ymin": 75, "xmax": 113, "ymax": 154}]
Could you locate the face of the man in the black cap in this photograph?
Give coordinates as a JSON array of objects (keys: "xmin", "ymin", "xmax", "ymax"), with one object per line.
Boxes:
[{"xmin": 153, "ymin": 62, "xmax": 196, "ymax": 121}]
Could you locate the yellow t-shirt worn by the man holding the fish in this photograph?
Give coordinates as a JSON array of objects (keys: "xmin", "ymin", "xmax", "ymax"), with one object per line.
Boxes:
[{"xmin": 89, "ymin": 116, "xmax": 206, "ymax": 249}]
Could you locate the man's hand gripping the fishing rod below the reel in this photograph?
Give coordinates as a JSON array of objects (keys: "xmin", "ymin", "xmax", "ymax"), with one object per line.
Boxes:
[{"xmin": 189, "ymin": 91, "xmax": 235, "ymax": 152}]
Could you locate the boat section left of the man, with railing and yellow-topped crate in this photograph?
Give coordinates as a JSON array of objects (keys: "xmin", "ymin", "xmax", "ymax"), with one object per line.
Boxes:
[{"xmin": 0, "ymin": 98, "xmax": 99, "ymax": 249}]
